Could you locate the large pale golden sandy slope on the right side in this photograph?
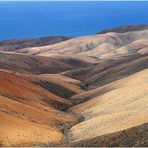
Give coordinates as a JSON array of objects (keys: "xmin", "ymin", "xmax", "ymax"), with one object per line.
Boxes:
[{"xmin": 70, "ymin": 69, "xmax": 148, "ymax": 143}]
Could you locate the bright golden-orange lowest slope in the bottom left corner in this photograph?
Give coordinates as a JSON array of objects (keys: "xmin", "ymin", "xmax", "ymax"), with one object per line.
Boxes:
[{"xmin": 0, "ymin": 112, "xmax": 63, "ymax": 146}]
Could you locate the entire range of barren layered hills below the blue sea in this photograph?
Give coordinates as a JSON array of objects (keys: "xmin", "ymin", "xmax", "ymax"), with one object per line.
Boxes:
[{"xmin": 0, "ymin": 25, "xmax": 148, "ymax": 146}]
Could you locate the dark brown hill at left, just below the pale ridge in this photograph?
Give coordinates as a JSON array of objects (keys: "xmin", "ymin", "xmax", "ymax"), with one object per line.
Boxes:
[{"xmin": 0, "ymin": 52, "xmax": 97, "ymax": 74}]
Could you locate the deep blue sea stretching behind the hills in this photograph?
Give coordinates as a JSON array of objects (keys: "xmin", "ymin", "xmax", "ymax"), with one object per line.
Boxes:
[{"xmin": 0, "ymin": 1, "xmax": 148, "ymax": 40}]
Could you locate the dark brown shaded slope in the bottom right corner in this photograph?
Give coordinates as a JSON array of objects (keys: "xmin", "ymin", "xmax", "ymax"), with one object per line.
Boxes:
[{"xmin": 70, "ymin": 123, "xmax": 148, "ymax": 147}]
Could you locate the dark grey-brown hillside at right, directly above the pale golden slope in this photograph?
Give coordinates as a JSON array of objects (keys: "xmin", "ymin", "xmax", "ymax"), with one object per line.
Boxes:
[{"xmin": 63, "ymin": 54, "xmax": 148, "ymax": 89}]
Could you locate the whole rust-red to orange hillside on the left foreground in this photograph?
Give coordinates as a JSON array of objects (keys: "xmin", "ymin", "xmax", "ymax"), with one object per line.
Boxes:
[{"xmin": 0, "ymin": 70, "xmax": 79, "ymax": 146}]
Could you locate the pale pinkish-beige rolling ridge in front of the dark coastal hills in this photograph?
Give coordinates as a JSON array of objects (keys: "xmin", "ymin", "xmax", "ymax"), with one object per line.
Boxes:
[{"xmin": 18, "ymin": 30, "xmax": 148, "ymax": 58}]
